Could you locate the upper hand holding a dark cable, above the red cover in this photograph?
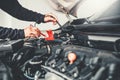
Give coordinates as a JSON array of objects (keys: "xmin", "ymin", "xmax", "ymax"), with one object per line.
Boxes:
[{"xmin": 44, "ymin": 13, "xmax": 57, "ymax": 25}]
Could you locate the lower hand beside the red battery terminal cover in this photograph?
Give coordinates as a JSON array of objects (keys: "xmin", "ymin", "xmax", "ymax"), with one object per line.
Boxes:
[{"xmin": 24, "ymin": 25, "xmax": 41, "ymax": 38}]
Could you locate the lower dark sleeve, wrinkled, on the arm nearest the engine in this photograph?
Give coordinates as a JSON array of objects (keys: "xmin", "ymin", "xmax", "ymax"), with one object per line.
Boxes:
[{"xmin": 0, "ymin": 27, "xmax": 25, "ymax": 40}]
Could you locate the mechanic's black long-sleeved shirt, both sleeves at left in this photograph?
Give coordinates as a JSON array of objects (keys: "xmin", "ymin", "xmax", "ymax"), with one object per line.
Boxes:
[{"xmin": 0, "ymin": 0, "xmax": 44, "ymax": 39}]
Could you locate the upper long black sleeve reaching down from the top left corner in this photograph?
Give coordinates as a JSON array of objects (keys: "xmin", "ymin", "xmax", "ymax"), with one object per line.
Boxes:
[{"xmin": 1, "ymin": 0, "xmax": 44, "ymax": 23}]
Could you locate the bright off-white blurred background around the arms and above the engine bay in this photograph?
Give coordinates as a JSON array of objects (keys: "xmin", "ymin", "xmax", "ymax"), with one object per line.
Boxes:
[{"xmin": 0, "ymin": 0, "xmax": 117, "ymax": 30}]
